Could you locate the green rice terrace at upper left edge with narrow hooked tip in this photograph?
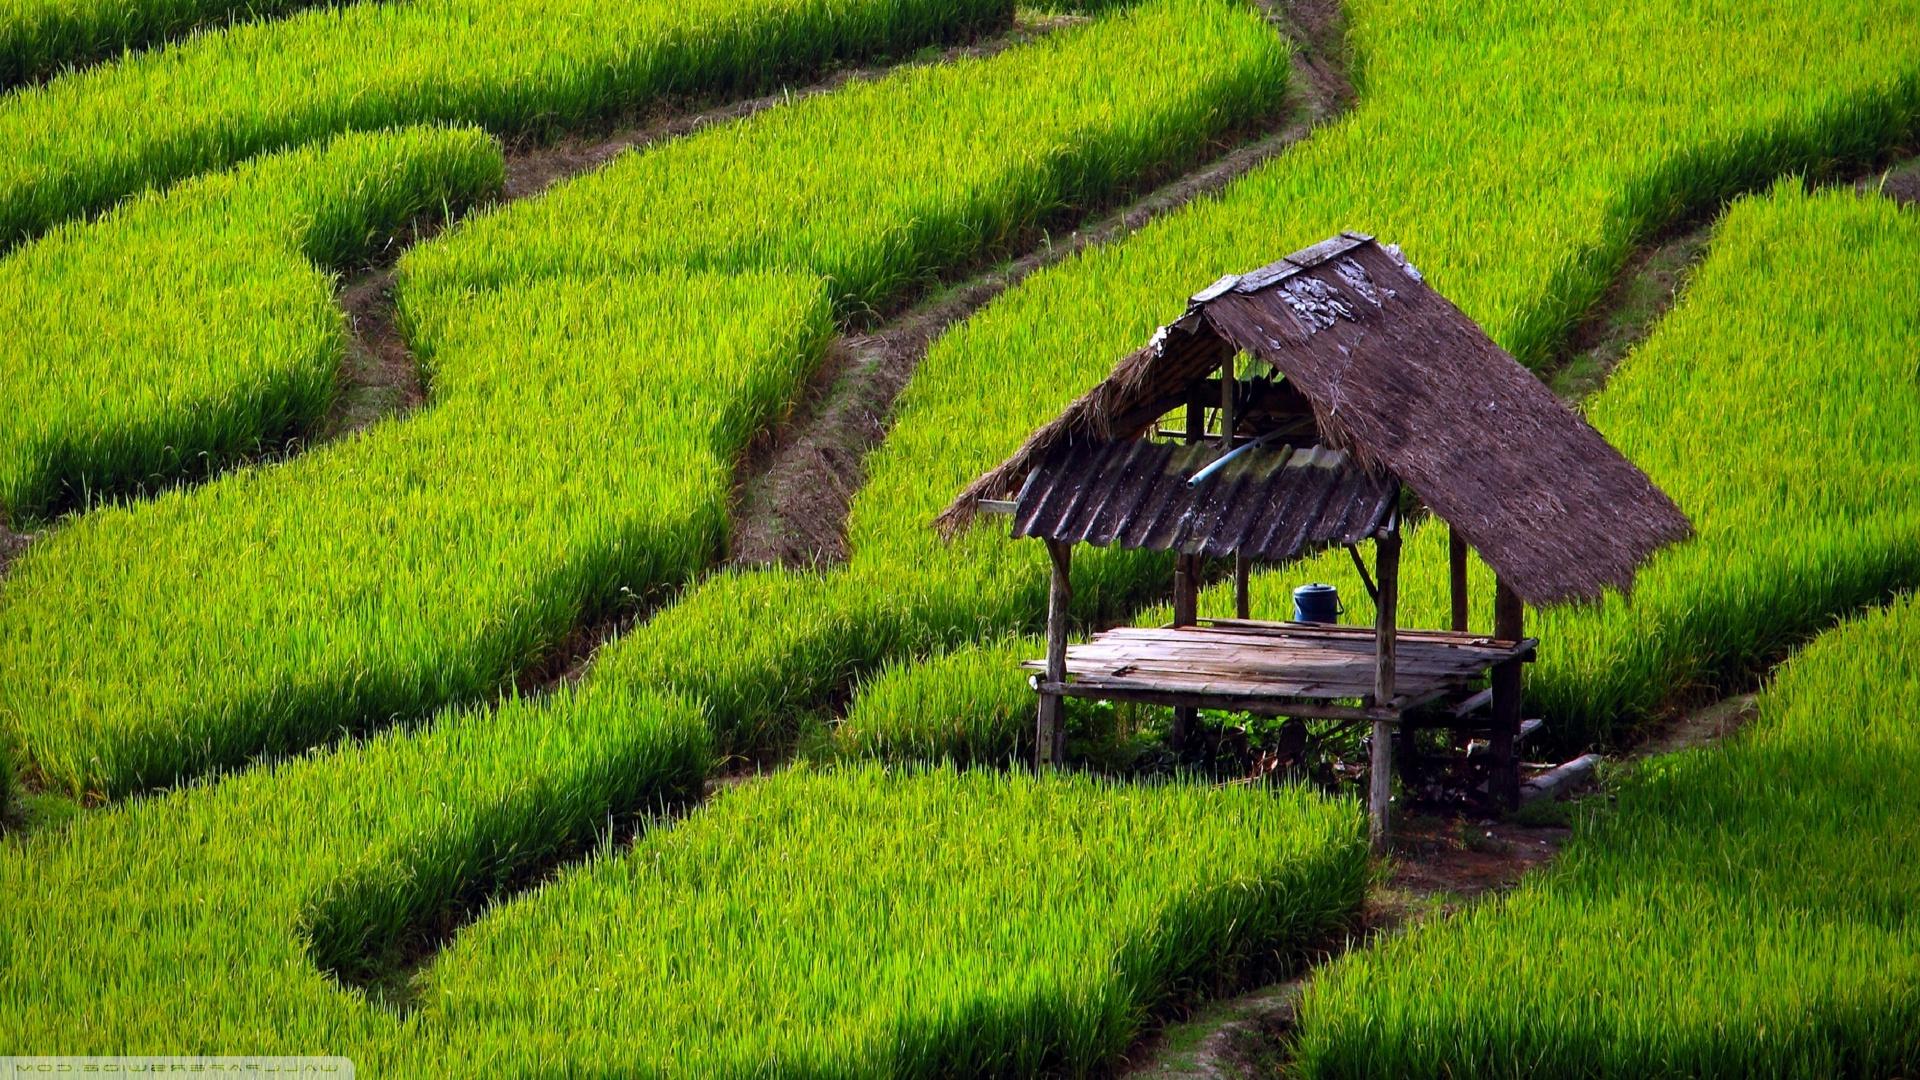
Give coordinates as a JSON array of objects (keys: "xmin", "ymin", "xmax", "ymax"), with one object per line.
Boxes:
[{"xmin": 0, "ymin": 129, "xmax": 503, "ymax": 523}]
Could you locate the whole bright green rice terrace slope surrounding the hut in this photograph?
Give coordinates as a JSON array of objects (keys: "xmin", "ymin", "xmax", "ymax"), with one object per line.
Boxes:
[{"xmin": 0, "ymin": 0, "xmax": 1920, "ymax": 1078}]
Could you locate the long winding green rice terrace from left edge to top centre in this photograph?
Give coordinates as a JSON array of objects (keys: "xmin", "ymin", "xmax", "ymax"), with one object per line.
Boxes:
[{"xmin": 0, "ymin": 0, "xmax": 1286, "ymax": 796}]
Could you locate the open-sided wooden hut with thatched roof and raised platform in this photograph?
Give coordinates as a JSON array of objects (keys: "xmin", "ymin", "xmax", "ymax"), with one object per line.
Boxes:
[{"xmin": 941, "ymin": 233, "xmax": 1692, "ymax": 844}]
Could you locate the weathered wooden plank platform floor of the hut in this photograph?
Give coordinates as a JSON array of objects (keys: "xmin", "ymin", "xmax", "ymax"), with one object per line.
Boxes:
[{"xmin": 1023, "ymin": 619, "xmax": 1536, "ymax": 719}]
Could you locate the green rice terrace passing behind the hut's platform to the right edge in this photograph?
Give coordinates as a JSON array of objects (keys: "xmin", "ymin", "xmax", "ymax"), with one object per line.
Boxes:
[{"xmin": 837, "ymin": 170, "xmax": 1920, "ymax": 757}]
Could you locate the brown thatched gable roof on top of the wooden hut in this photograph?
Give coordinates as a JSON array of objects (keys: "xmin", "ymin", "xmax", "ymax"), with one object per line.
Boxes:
[{"xmin": 941, "ymin": 233, "xmax": 1692, "ymax": 605}]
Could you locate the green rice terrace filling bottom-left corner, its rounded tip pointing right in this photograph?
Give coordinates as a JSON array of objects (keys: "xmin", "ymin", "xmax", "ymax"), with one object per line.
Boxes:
[{"xmin": 0, "ymin": 676, "xmax": 712, "ymax": 1045}]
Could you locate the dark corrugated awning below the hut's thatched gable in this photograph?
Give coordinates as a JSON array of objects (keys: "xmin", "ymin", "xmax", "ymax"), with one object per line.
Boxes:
[{"xmin": 1014, "ymin": 438, "xmax": 1394, "ymax": 561}]
